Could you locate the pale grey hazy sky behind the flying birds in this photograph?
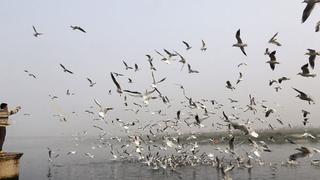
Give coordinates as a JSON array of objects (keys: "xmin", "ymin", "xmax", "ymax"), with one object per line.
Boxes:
[{"xmin": 0, "ymin": 0, "xmax": 320, "ymax": 136}]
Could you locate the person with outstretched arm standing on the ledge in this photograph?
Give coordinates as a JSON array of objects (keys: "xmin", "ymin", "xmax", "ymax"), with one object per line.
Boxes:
[{"xmin": 0, "ymin": 103, "xmax": 21, "ymax": 153}]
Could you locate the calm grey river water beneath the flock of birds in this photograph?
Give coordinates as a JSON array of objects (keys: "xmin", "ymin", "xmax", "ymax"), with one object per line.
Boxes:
[{"xmin": 5, "ymin": 137, "xmax": 320, "ymax": 180}]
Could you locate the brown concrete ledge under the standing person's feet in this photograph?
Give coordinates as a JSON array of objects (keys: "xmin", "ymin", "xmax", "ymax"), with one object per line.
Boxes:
[{"xmin": 0, "ymin": 152, "xmax": 23, "ymax": 180}]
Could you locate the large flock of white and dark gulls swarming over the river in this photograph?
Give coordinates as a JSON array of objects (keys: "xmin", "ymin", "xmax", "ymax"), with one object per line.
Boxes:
[{"xmin": 25, "ymin": 3, "xmax": 320, "ymax": 179}]
